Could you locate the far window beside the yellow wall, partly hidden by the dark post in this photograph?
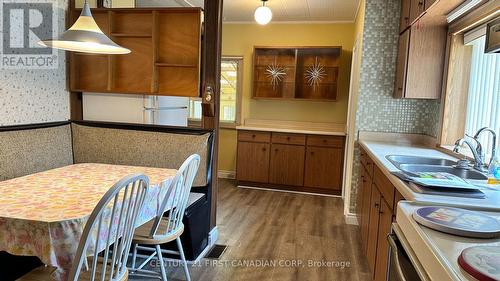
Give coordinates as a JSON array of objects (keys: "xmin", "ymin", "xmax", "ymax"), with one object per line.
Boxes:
[{"xmin": 189, "ymin": 57, "xmax": 243, "ymax": 127}]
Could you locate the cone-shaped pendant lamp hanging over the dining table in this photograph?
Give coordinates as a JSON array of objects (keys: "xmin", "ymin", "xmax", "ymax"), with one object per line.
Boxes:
[{"xmin": 38, "ymin": 0, "xmax": 130, "ymax": 55}]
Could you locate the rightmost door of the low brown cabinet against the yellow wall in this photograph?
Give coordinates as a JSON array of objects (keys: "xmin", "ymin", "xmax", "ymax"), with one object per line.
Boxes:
[{"xmin": 304, "ymin": 147, "xmax": 344, "ymax": 191}]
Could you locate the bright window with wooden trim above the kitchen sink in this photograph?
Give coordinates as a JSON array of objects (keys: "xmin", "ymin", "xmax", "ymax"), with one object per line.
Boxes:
[{"xmin": 440, "ymin": 18, "xmax": 500, "ymax": 160}]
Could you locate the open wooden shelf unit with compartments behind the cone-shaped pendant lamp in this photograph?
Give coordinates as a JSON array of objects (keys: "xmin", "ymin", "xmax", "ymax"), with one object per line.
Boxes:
[{"xmin": 70, "ymin": 8, "xmax": 202, "ymax": 97}]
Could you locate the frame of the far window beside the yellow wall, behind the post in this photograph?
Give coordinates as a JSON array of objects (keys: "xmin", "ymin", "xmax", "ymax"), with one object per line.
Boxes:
[{"xmin": 188, "ymin": 56, "xmax": 244, "ymax": 129}]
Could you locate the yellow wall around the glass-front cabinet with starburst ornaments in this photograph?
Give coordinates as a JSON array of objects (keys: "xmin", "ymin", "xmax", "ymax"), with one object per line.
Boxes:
[{"xmin": 219, "ymin": 23, "xmax": 355, "ymax": 171}]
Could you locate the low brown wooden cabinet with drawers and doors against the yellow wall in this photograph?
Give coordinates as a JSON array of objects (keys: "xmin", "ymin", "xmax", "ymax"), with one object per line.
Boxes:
[{"xmin": 236, "ymin": 130, "xmax": 345, "ymax": 195}]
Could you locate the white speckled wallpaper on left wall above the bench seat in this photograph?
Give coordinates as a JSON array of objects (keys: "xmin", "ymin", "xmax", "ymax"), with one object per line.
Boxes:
[{"xmin": 0, "ymin": 0, "xmax": 69, "ymax": 126}]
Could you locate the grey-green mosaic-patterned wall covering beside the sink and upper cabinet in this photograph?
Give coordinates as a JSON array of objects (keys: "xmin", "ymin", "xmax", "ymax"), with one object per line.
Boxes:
[{"xmin": 350, "ymin": 0, "xmax": 440, "ymax": 213}]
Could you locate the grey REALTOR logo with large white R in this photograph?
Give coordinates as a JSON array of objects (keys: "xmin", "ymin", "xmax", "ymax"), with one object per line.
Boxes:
[{"xmin": 0, "ymin": 0, "xmax": 57, "ymax": 69}]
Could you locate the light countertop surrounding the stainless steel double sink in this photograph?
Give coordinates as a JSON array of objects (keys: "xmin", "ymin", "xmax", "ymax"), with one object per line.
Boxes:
[{"xmin": 359, "ymin": 140, "xmax": 500, "ymax": 211}]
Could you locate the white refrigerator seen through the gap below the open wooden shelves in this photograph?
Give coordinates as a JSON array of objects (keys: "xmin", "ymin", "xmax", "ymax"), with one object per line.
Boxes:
[{"xmin": 83, "ymin": 93, "xmax": 189, "ymax": 127}]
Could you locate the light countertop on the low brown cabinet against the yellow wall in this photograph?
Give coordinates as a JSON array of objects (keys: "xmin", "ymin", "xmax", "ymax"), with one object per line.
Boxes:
[{"xmin": 236, "ymin": 119, "xmax": 346, "ymax": 136}]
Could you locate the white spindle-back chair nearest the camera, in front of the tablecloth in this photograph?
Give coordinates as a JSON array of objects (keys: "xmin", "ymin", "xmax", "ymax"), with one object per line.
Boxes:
[{"xmin": 18, "ymin": 174, "xmax": 149, "ymax": 281}]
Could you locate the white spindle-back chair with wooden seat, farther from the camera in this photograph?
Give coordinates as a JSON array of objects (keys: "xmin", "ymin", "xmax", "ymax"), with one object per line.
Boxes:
[{"xmin": 130, "ymin": 154, "xmax": 200, "ymax": 281}]
